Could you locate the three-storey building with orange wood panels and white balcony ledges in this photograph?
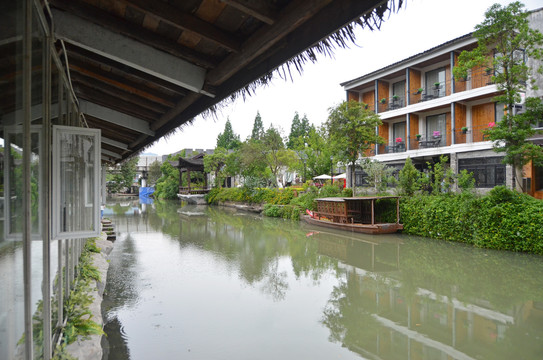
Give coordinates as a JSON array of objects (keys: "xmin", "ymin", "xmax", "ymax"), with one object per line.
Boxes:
[{"xmin": 341, "ymin": 9, "xmax": 543, "ymax": 198}]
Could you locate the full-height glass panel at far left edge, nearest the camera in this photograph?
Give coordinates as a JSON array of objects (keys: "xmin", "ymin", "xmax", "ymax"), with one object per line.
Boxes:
[{"xmin": 0, "ymin": 1, "xmax": 24, "ymax": 359}]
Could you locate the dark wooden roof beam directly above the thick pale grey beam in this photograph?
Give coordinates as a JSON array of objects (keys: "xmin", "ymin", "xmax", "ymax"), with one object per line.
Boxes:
[{"xmin": 49, "ymin": 0, "xmax": 219, "ymax": 68}]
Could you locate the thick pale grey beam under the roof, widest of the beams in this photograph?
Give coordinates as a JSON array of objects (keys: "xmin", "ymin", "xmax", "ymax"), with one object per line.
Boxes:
[{"xmin": 51, "ymin": 9, "xmax": 206, "ymax": 92}]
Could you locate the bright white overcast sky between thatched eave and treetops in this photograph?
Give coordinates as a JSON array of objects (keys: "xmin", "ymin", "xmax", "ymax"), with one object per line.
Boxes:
[{"xmin": 146, "ymin": 0, "xmax": 543, "ymax": 155}]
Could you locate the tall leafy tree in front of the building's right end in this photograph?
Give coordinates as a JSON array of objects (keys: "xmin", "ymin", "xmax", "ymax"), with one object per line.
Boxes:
[{"xmin": 453, "ymin": 1, "xmax": 543, "ymax": 189}]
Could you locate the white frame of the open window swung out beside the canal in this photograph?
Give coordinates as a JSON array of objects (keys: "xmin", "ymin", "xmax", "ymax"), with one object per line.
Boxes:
[{"xmin": 52, "ymin": 125, "xmax": 101, "ymax": 240}]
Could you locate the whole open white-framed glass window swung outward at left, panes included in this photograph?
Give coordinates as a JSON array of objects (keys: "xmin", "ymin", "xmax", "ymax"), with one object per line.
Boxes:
[{"xmin": 53, "ymin": 126, "xmax": 100, "ymax": 239}]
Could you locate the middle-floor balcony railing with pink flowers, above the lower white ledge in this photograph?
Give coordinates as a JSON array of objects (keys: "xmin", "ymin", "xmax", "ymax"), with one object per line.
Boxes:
[{"xmin": 372, "ymin": 125, "xmax": 496, "ymax": 155}]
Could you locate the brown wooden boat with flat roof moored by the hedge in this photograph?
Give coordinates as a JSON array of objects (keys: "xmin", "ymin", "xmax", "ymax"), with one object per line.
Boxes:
[{"xmin": 302, "ymin": 196, "xmax": 403, "ymax": 235}]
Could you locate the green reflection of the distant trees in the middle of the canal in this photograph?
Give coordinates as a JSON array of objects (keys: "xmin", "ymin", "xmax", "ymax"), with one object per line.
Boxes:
[{"xmin": 140, "ymin": 201, "xmax": 335, "ymax": 300}]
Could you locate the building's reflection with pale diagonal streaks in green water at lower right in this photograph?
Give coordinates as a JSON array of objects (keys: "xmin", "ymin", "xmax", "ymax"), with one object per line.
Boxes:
[{"xmin": 318, "ymin": 235, "xmax": 543, "ymax": 359}]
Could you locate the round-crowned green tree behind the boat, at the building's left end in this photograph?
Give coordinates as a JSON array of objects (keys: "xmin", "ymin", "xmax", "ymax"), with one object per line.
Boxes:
[{"xmin": 325, "ymin": 100, "xmax": 384, "ymax": 191}]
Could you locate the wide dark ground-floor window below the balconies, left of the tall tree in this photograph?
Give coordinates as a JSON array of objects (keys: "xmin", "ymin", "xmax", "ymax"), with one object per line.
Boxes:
[{"xmin": 458, "ymin": 157, "xmax": 505, "ymax": 188}]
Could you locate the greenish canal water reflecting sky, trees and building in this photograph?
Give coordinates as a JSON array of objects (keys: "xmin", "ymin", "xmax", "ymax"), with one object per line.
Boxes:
[{"xmin": 103, "ymin": 200, "xmax": 543, "ymax": 360}]
